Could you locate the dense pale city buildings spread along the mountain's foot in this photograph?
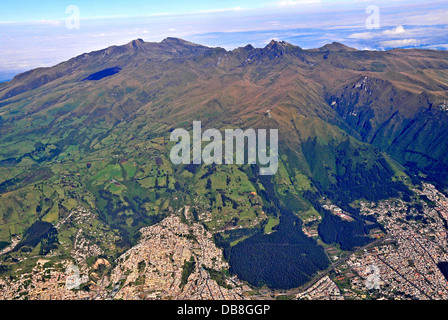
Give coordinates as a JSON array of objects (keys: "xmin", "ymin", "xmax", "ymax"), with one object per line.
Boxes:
[{"xmin": 0, "ymin": 184, "xmax": 448, "ymax": 300}]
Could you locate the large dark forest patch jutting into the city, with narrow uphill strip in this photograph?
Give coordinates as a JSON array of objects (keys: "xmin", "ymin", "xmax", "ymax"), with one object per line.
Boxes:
[{"xmin": 228, "ymin": 166, "xmax": 329, "ymax": 289}]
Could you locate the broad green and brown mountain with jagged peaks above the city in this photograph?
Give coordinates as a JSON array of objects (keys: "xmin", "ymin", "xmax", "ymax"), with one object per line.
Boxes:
[{"xmin": 0, "ymin": 38, "xmax": 448, "ymax": 289}]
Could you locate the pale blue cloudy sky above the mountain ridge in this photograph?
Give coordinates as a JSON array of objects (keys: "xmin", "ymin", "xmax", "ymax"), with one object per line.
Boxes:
[{"xmin": 0, "ymin": 0, "xmax": 448, "ymax": 81}]
